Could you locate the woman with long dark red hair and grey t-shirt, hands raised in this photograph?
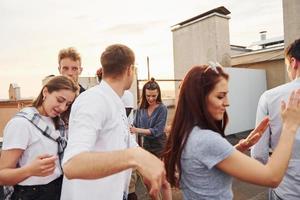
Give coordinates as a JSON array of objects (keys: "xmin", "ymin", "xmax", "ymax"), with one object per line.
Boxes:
[{"xmin": 164, "ymin": 65, "xmax": 300, "ymax": 200}]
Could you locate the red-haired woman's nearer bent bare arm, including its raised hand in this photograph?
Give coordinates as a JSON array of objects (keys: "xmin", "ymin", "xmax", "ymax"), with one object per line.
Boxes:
[{"xmin": 217, "ymin": 90, "xmax": 300, "ymax": 187}]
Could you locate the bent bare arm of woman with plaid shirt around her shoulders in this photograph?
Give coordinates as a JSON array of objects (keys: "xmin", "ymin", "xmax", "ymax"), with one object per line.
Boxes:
[{"xmin": 0, "ymin": 149, "xmax": 57, "ymax": 185}]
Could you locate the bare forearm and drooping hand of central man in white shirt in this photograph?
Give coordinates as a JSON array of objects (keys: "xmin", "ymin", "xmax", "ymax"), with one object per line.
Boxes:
[{"xmin": 63, "ymin": 147, "xmax": 165, "ymax": 196}]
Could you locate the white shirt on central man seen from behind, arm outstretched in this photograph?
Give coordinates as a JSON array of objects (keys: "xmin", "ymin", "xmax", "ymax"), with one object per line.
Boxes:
[{"xmin": 61, "ymin": 80, "xmax": 136, "ymax": 200}]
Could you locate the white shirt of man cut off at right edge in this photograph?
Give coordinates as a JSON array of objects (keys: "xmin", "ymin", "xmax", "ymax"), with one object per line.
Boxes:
[{"xmin": 251, "ymin": 78, "xmax": 300, "ymax": 200}]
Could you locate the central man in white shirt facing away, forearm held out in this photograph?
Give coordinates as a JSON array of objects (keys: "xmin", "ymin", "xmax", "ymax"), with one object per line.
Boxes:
[{"xmin": 61, "ymin": 44, "xmax": 170, "ymax": 200}]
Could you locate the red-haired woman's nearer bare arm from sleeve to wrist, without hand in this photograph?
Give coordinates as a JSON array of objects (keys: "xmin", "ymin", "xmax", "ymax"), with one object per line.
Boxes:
[{"xmin": 217, "ymin": 124, "xmax": 295, "ymax": 187}]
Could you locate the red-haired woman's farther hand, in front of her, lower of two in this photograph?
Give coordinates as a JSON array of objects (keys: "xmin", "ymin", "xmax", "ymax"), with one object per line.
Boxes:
[{"xmin": 235, "ymin": 117, "xmax": 270, "ymax": 152}]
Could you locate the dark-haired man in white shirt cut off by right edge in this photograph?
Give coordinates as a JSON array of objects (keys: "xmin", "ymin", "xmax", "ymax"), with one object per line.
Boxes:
[{"xmin": 251, "ymin": 39, "xmax": 300, "ymax": 200}]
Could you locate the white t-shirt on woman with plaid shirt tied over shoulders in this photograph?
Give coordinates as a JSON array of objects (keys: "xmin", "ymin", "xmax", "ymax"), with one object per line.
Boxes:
[{"xmin": 2, "ymin": 116, "xmax": 62, "ymax": 185}]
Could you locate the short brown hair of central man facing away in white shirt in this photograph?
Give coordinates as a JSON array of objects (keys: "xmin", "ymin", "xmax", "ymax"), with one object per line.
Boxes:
[{"xmin": 100, "ymin": 44, "xmax": 135, "ymax": 78}]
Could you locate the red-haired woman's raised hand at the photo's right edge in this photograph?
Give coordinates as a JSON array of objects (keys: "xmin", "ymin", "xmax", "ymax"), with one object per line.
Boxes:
[{"xmin": 281, "ymin": 89, "xmax": 300, "ymax": 128}]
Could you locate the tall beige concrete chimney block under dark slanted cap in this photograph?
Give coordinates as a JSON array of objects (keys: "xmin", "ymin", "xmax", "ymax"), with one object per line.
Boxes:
[{"xmin": 172, "ymin": 13, "xmax": 230, "ymax": 81}]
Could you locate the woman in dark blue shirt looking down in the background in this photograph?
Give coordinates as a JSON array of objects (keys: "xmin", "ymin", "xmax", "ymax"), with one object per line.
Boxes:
[{"xmin": 130, "ymin": 78, "xmax": 168, "ymax": 157}]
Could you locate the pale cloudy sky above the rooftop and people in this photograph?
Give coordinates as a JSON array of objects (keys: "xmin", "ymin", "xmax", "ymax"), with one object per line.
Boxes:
[{"xmin": 0, "ymin": 0, "xmax": 283, "ymax": 99}]
